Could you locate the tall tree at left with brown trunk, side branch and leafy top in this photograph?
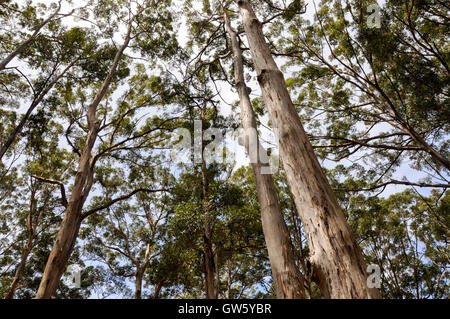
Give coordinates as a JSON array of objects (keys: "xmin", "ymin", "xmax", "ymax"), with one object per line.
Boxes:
[{"xmin": 36, "ymin": 1, "xmax": 178, "ymax": 298}]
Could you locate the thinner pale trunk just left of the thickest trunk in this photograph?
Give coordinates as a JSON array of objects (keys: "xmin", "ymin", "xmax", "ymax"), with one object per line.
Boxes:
[{"xmin": 224, "ymin": 13, "xmax": 304, "ymax": 299}]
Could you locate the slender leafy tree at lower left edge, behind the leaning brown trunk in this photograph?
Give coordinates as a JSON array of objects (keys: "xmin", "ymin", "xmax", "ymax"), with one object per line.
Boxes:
[{"xmin": 0, "ymin": 112, "xmax": 78, "ymax": 299}]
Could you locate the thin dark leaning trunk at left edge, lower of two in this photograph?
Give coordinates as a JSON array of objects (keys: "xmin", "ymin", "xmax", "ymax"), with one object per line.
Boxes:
[{"xmin": 0, "ymin": 58, "xmax": 78, "ymax": 161}]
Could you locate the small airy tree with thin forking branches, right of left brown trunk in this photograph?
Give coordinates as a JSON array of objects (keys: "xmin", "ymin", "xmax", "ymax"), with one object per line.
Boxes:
[{"xmin": 80, "ymin": 145, "xmax": 173, "ymax": 299}]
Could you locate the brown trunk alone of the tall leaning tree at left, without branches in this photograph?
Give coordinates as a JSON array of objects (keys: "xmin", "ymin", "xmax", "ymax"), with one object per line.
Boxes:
[{"xmin": 36, "ymin": 18, "xmax": 134, "ymax": 299}]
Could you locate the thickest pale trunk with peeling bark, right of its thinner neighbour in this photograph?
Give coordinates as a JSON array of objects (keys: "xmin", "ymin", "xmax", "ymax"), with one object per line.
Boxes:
[{"xmin": 236, "ymin": 0, "xmax": 380, "ymax": 298}]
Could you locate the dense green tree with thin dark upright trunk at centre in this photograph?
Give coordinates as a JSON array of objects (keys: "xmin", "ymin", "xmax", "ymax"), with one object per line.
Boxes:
[{"xmin": 153, "ymin": 68, "xmax": 270, "ymax": 298}]
